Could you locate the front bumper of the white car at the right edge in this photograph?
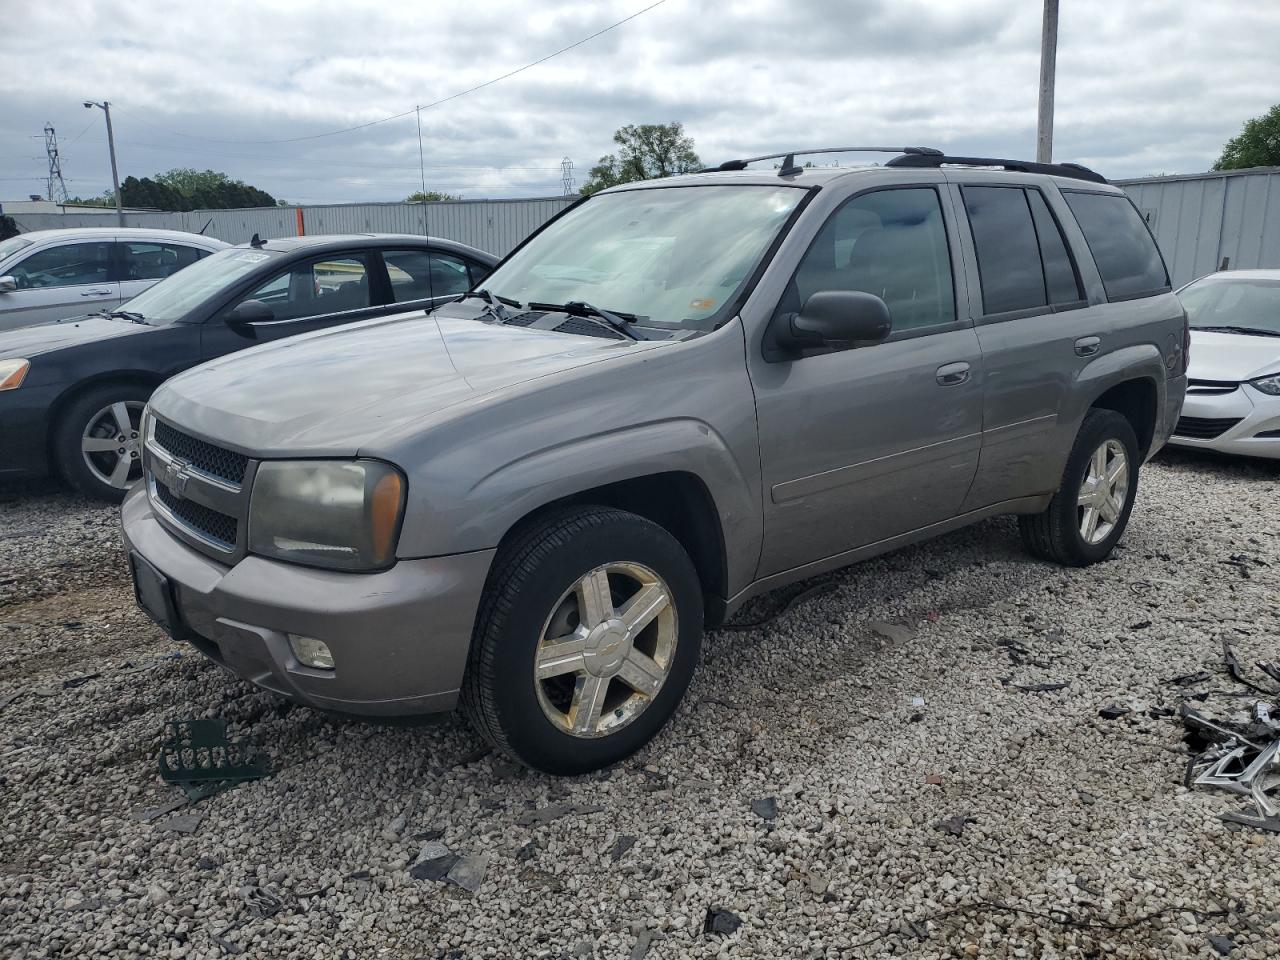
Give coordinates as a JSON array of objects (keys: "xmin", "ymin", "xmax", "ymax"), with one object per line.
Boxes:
[{"xmin": 1169, "ymin": 384, "xmax": 1280, "ymax": 458}]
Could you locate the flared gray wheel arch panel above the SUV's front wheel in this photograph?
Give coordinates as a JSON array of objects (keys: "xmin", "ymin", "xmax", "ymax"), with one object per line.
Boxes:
[{"xmin": 399, "ymin": 417, "xmax": 763, "ymax": 591}]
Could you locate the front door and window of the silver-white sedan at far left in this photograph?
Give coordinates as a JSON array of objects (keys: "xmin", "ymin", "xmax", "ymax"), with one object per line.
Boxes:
[{"xmin": 0, "ymin": 239, "xmax": 120, "ymax": 329}]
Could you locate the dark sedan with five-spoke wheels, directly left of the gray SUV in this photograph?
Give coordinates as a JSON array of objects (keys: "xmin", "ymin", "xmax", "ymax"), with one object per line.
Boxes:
[{"xmin": 0, "ymin": 234, "xmax": 497, "ymax": 500}]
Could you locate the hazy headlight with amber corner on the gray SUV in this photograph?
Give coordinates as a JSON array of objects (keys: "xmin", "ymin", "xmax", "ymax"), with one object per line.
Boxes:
[{"xmin": 248, "ymin": 460, "xmax": 406, "ymax": 571}]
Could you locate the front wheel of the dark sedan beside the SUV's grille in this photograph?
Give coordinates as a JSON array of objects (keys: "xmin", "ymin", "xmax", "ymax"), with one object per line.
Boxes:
[{"xmin": 52, "ymin": 383, "xmax": 151, "ymax": 503}]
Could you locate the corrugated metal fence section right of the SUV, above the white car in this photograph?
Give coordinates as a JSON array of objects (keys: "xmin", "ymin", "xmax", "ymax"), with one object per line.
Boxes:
[{"xmin": 1116, "ymin": 166, "xmax": 1280, "ymax": 287}]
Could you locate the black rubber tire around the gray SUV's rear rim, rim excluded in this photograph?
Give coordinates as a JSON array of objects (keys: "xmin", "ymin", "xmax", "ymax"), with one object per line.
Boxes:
[{"xmin": 1018, "ymin": 410, "xmax": 1140, "ymax": 567}]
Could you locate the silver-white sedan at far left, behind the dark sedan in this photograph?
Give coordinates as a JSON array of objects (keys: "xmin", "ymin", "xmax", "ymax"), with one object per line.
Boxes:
[{"xmin": 0, "ymin": 227, "xmax": 228, "ymax": 330}]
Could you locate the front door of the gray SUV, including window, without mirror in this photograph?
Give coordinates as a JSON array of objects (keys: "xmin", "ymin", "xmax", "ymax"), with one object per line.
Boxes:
[{"xmin": 751, "ymin": 186, "xmax": 983, "ymax": 577}]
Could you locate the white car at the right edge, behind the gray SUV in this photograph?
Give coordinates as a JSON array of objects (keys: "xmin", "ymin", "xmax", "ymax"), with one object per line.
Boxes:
[{"xmin": 1169, "ymin": 270, "xmax": 1280, "ymax": 458}]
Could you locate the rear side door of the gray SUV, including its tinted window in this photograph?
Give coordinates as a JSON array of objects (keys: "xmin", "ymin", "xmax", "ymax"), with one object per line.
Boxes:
[{"xmin": 952, "ymin": 179, "xmax": 1098, "ymax": 511}]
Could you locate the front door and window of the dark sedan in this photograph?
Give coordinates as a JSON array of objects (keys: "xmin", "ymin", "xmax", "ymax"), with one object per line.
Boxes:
[{"xmin": 202, "ymin": 250, "xmax": 390, "ymax": 357}]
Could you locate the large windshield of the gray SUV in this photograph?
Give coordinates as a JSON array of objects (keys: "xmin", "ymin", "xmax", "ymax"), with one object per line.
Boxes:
[{"xmin": 484, "ymin": 186, "xmax": 804, "ymax": 330}]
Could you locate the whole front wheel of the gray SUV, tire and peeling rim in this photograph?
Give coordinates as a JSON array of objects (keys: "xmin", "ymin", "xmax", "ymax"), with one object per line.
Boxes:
[{"xmin": 462, "ymin": 507, "xmax": 703, "ymax": 774}]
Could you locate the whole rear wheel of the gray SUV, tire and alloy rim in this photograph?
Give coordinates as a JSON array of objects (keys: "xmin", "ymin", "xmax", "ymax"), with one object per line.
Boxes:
[{"xmin": 1018, "ymin": 410, "xmax": 1140, "ymax": 567}]
